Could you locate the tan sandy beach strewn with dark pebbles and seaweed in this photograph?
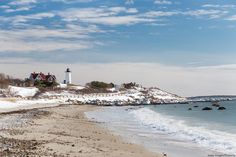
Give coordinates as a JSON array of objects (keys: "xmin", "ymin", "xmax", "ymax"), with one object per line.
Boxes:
[{"xmin": 0, "ymin": 105, "xmax": 163, "ymax": 157}]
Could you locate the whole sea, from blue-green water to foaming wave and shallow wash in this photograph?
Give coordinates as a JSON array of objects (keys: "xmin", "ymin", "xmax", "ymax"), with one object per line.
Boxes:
[{"xmin": 86, "ymin": 101, "xmax": 236, "ymax": 157}]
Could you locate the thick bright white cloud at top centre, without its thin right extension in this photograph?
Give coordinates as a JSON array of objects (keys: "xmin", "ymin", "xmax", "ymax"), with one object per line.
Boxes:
[{"xmin": 58, "ymin": 7, "xmax": 155, "ymax": 25}]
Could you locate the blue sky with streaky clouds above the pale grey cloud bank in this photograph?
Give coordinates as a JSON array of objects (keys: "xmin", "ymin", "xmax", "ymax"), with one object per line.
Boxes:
[{"xmin": 0, "ymin": 0, "xmax": 236, "ymax": 66}]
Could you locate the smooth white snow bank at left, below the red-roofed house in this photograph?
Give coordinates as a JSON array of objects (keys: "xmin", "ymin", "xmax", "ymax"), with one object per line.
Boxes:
[{"xmin": 8, "ymin": 86, "xmax": 39, "ymax": 98}]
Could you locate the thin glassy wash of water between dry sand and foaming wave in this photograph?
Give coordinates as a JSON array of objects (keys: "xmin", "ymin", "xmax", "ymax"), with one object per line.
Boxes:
[{"xmin": 86, "ymin": 104, "xmax": 225, "ymax": 157}]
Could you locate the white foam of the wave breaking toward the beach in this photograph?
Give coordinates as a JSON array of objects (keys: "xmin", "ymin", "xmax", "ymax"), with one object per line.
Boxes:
[{"xmin": 129, "ymin": 108, "xmax": 236, "ymax": 154}]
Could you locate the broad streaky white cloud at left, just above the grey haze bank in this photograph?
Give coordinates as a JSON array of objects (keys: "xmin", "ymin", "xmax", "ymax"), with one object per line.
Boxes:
[{"xmin": 0, "ymin": 25, "xmax": 103, "ymax": 53}]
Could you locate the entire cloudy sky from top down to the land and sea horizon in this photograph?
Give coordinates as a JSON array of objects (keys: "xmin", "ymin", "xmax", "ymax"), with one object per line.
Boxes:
[{"xmin": 0, "ymin": 0, "xmax": 236, "ymax": 96}]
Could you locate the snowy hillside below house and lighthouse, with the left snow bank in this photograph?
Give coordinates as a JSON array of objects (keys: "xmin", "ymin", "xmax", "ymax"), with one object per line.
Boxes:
[{"xmin": 2, "ymin": 86, "xmax": 186, "ymax": 105}]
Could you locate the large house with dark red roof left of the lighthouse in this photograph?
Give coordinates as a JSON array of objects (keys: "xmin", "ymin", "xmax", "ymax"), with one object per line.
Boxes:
[{"xmin": 29, "ymin": 72, "xmax": 56, "ymax": 82}]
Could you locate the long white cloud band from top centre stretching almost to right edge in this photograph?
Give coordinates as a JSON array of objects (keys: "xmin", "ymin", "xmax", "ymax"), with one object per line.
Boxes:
[{"xmin": 56, "ymin": 7, "xmax": 228, "ymax": 25}]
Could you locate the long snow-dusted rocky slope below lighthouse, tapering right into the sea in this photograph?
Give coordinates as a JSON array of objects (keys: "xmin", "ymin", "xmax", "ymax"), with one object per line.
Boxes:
[{"xmin": 40, "ymin": 87, "xmax": 186, "ymax": 105}]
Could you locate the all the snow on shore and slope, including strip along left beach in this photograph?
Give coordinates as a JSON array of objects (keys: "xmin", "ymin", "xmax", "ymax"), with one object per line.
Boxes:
[{"xmin": 0, "ymin": 86, "xmax": 186, "ymax": 112}]
